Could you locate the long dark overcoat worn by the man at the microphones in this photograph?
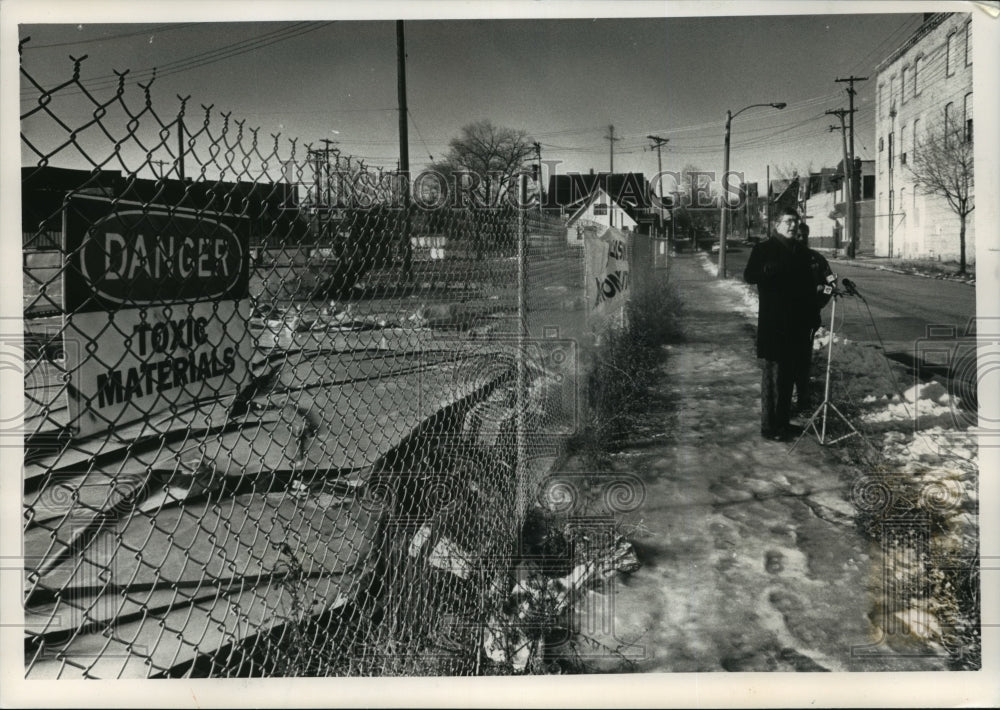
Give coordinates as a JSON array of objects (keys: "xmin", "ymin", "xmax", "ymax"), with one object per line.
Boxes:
[{"xmin": 743, "ymin": 237, "xmax": 820, "ymax": 360}]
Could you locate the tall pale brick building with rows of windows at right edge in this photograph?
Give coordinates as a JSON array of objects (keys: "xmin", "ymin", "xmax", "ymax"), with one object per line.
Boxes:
[{"xmin": 875, "ymin": 13, "xmax": 975, "ymax": 263}]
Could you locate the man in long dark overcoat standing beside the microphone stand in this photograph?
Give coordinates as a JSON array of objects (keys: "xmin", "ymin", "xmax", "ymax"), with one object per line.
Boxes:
[{"xmin": 743, "ymin": 207, "xmax": 820, "ymax": 441}]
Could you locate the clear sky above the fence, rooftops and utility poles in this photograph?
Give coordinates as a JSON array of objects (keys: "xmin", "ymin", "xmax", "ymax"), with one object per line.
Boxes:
[{"xmin": 9, "ymin": 3, "xmax": 944, "ymax": 192}]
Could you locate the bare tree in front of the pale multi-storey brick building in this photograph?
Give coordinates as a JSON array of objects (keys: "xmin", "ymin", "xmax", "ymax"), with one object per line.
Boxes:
[{"xmin": 910, "ymin": 119, "xmax": 976, "ymax": 274}]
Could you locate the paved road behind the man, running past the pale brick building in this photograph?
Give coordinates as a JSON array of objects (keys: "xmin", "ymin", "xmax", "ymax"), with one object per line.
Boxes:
[{"xmin": 712, "ymin": 247, "xmax": 976, "ymax": 372}]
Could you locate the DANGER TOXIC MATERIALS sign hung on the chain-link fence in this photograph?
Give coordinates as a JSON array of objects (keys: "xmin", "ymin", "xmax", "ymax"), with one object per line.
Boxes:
[{"xmin": 64, "ymin": 196, "xmax": 253, "ymax": 436}]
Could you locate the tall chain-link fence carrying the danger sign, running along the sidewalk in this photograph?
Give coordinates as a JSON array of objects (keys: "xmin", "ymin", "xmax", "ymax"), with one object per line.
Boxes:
[{"xmin": 22, "ymin": 48, "xmax": 627, "ymax": 678}]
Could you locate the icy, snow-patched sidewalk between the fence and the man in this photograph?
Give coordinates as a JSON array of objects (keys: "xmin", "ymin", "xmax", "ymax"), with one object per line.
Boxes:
[{"xmin": 568, "ymin": 255, "xmax": 945, "ymax": 672}]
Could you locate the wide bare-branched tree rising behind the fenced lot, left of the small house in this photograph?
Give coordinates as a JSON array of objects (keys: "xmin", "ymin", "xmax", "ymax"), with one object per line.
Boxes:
[{"xmin": 431, "ymin": 120, "xmax": 534, "ymax": 206}]
